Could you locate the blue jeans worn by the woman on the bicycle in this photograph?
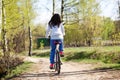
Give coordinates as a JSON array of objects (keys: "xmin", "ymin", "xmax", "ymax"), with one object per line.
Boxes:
[{"xmin": 50, "ymin": 39, "xmax": 63, "ymax": 64}]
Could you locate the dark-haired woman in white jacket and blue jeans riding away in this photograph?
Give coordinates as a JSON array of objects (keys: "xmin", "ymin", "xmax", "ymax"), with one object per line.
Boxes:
[{"xmin": 46, "ymin": 14, "xmax": 65, "ymax": 69}]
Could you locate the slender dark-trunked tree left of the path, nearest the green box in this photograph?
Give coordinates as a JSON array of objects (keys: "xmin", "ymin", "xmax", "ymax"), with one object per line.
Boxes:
[{"xmin": 19, "ymin": 0, "xmax": 35, "ymax": 56}]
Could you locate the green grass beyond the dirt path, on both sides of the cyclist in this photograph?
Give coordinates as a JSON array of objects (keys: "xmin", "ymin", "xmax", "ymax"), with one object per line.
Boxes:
[{"xmin": 33, "ymin": 46, "xmax": 120, "ymax": 69}]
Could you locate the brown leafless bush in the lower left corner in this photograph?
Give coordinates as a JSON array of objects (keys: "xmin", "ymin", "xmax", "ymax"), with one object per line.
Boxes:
[{"xmin": 0, "ymin": 56, "xmax": 23, "ymax": 77}]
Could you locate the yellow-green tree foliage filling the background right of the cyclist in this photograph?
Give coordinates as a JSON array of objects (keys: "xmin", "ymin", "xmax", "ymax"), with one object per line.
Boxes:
[{"xmin": 64, "ymin": 0, "xmax": 120, "ymax": 46}]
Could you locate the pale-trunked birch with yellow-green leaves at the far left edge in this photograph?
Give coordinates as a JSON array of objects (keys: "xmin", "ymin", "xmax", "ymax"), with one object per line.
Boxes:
[{"xmin": 1, "ymin": 0, "xmax": 23, "ymax": 74}]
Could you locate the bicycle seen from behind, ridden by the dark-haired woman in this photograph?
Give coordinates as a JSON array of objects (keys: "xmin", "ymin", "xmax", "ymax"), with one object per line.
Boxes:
[{"xmin": 54, "ymin": 41, "xmax": 62, "ymax": 74}]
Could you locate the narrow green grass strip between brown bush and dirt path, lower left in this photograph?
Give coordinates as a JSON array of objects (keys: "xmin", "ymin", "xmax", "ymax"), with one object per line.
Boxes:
[{"xmin": 5, "ymin": 62, "xmax": 32, "ymax": 79}]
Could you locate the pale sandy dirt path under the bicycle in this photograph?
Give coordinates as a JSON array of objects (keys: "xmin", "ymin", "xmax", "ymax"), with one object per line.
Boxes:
[{"xmin": 11, "ymin": 57, "xmax": 120, "ymax": 80}]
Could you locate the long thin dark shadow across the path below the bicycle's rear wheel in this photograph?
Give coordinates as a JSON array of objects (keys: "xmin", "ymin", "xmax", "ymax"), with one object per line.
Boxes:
[{"xmin": 7, "ymin": 69, "xmax": 118, "ymax": 79}]
